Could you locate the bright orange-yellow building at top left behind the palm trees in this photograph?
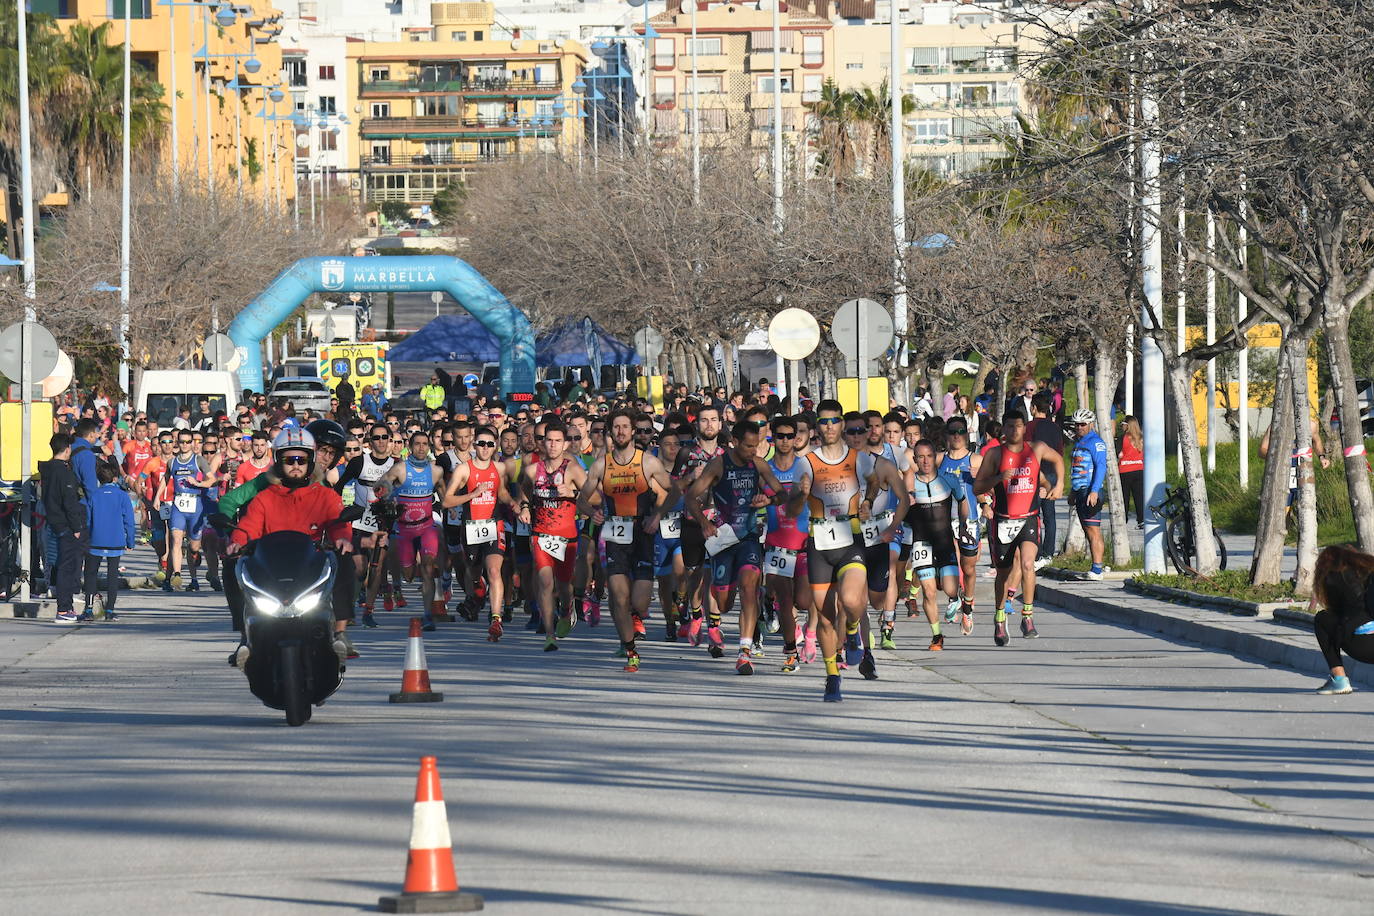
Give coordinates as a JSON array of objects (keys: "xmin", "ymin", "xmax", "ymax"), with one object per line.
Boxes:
[{"xmin": 30, "ymin": 0, "xmax": 295, "ymax": 203}]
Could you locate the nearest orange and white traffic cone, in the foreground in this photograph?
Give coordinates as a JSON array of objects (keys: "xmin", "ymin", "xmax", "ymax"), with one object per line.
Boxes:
[{"xmin": 378, "ymin": 757, "xmax": 482, "ymax": 913}]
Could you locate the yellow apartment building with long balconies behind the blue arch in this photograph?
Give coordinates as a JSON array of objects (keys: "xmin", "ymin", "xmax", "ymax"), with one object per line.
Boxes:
[{"xmin": 348, "ymin": 3, "xmax": 589, "ymax": 203}]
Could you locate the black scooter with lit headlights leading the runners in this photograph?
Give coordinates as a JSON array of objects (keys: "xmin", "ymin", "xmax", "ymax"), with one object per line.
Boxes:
[{"xmin": 210, "ymin": 507, "xmax": 363, "ymax": 725}]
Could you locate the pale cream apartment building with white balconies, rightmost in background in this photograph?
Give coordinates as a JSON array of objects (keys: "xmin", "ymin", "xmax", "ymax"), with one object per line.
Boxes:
[{"xmin": 834, "ymin": 7, "xmax": 1031, "ymax": 174}]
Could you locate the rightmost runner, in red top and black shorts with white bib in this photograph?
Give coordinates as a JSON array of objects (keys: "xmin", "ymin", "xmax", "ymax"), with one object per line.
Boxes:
[{"xmin": 973, "ymin": 411, "xmax": 1063, "ymax": 645}]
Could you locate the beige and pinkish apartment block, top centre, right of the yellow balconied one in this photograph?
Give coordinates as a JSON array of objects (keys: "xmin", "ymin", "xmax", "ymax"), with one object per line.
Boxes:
[{"xmin": 638, "ymin": 0, "xmax": 834, "ymax": 146}]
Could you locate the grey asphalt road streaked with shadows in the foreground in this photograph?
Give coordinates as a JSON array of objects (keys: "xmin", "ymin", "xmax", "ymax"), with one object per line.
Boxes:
[{"xmin": 0, "ymin": 560, "xmax": 1374, "ymax": 916}]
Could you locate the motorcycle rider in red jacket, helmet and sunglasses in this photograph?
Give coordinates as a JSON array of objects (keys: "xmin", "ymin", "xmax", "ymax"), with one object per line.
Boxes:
[{"xmin": 225, "ymin": 428, "xmax": 354, "ymax": 670}]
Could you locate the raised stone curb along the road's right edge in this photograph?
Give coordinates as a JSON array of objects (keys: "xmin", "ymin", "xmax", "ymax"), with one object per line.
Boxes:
[{"xmin": 1037, "ymin": 582, "xmax": 1374, "ymax": 688}]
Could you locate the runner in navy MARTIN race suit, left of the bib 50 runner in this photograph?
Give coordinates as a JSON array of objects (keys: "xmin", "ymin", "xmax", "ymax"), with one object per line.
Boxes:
[{"xmin": 687, "ymin": 420, "xmax": 802, "ymax": 674}]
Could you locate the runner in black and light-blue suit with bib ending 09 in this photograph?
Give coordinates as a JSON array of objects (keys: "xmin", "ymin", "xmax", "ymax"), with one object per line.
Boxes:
[{"xmin": 907, "ymin": 439, "xmax": 977, "ymax": 652}]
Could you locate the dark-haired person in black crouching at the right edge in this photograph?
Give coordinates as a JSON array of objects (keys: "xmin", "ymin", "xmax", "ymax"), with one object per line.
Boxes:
[{"xmin": 1308, "ymin": 545, "xmax": 1374, "ymax": 694}]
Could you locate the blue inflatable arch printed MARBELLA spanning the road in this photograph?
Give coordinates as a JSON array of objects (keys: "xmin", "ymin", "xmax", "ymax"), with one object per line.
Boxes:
[{"xmin": 228, "ymin": 255, "xmax": 534, "ymax": 400}]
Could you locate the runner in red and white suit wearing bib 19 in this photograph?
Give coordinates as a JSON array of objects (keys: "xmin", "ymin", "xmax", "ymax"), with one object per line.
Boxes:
[{"xmin": 444, "ymin": 426, "xmax": 515, "ymax": 643}]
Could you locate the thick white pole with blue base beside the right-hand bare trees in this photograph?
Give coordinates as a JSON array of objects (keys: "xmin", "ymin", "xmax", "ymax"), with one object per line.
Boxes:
[{"xmin": 1140, "ymin": 82, "xmax": 1164, "ymax": 573}]
